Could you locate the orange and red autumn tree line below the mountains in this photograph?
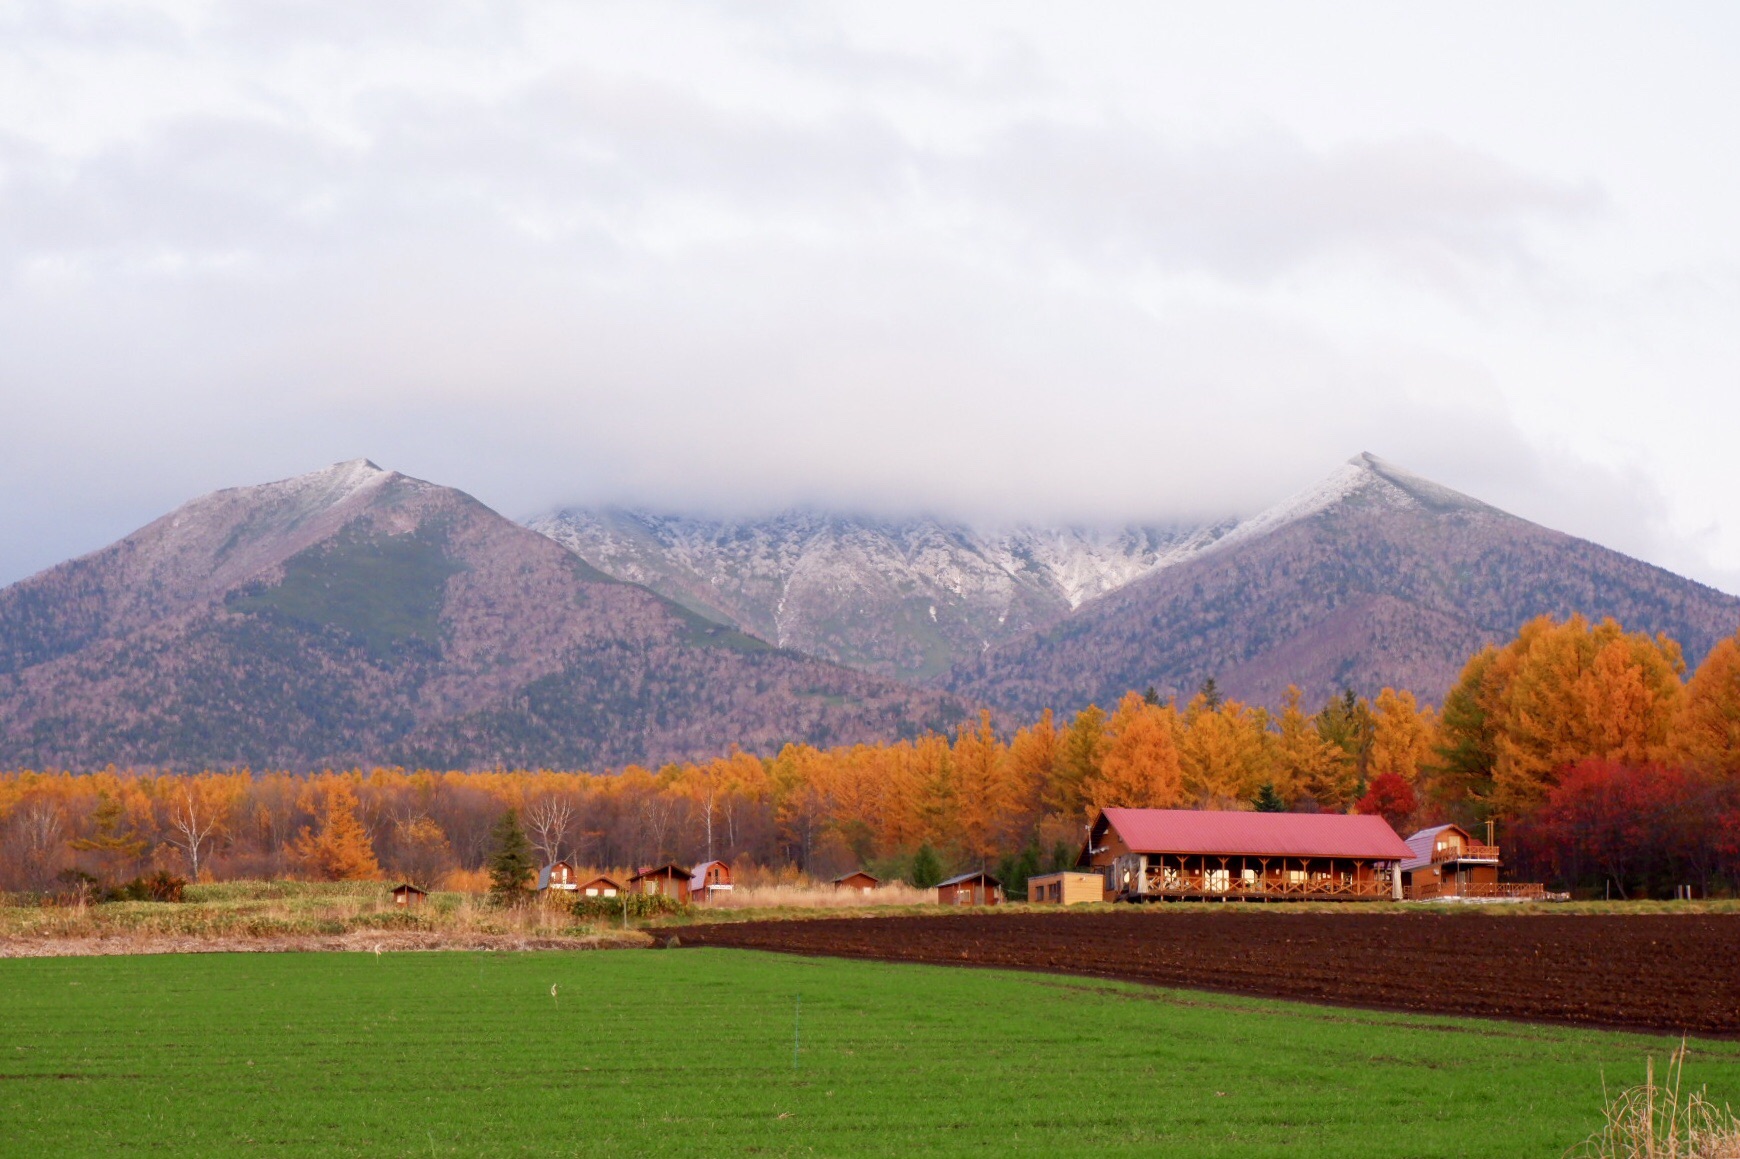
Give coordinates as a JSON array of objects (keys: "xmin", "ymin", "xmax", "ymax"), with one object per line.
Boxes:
[{"xmin": 0, "ymin": 618, "xmax": 1740, "ymax": 893}]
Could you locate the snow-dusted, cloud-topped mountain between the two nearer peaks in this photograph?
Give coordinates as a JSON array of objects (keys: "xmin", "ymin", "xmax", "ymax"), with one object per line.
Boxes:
[{"xmin": 529, "ymin": 508, "xmax": 1230, "ymax": 680}]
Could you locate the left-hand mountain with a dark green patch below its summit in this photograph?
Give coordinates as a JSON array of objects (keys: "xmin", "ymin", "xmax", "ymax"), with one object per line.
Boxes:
[{"xmin": 0, "ymin": 461, "xmax": 962, "ymax": 767}]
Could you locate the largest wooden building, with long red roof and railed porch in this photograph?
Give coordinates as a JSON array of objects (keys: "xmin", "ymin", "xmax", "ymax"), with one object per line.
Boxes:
[{"xmin": 1077, "ymin": 809, "xmax": 1413, "ymax": 901}]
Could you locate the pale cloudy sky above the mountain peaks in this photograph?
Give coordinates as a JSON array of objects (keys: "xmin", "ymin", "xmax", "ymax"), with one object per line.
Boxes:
[{"xmin": 0, "ymin": 0, "xmax": 1740, "ymax": 592}]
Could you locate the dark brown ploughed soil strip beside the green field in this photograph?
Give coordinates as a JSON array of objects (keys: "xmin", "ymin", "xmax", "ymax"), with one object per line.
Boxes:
[{"xmin": 675, "ymin": 908, "xmax": 1740, "ymax": 1037}]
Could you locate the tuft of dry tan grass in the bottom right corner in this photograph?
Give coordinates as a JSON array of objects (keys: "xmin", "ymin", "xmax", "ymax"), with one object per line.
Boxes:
[{"xmin": 1569, "ymin": 1041, "xmax": 1740, "ymax": 1159}]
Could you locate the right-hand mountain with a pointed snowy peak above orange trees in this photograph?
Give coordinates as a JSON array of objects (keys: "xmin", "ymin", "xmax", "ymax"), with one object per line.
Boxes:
[{"xmin": 947, "ymin": 454, "xmax": 1740, "ymax": 715}]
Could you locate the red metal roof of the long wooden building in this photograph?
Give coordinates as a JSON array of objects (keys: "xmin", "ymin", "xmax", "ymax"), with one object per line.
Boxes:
[{"xmin": 1105, "ymin": 809, "xmax": 1413, "ymax": 861}]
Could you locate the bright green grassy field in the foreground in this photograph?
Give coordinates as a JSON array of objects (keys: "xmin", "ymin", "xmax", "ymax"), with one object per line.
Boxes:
[{"xmin": 0, "ymin": 950, "xmax": 1740, "ymax": 1159}]
